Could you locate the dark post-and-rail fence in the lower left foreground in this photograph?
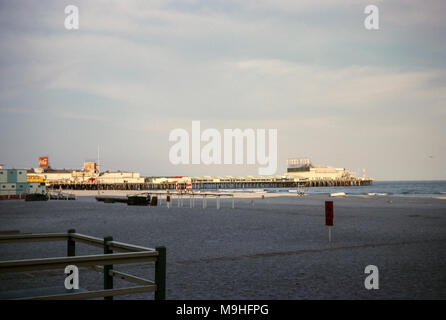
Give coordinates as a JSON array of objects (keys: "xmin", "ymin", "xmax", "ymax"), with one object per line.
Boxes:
[{"xmin": 0, "ymin": 229, "xmax": 166, "ymax": 300}]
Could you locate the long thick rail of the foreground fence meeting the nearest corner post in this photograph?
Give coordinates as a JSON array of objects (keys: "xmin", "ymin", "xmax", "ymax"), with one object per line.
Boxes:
[{"xmin": 0, "ymin": 251, "xmax": 158, "ymax": 273}]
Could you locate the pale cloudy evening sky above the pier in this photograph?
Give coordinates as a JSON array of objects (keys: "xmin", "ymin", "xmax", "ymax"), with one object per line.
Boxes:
[{"xmin": 0, "ymin": 0, "xmax": 446, "ymax": 180}]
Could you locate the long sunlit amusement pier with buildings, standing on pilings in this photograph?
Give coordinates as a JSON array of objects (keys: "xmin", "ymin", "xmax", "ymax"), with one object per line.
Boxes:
[{"xmin": 20, "ymin": 157, "xmax": 373, "ymax": 192}]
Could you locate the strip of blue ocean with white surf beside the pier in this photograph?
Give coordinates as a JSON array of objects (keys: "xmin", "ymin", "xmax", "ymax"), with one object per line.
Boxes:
[{"xmin": 218, "ymin": 180, "xmax": 446, "ymax": 197}]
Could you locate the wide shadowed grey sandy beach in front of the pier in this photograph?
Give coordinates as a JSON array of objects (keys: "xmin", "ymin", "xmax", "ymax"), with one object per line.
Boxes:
[{"xmin": 0, "ymin": 191, "xmax": 446, "ymax": 299}]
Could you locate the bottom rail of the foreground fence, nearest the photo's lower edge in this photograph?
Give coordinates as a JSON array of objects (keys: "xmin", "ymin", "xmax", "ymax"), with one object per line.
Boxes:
[{"xmin": 24, "ymin": 285, "xmax": 156, "ymax": 300}]
